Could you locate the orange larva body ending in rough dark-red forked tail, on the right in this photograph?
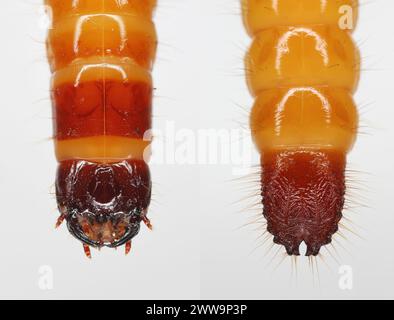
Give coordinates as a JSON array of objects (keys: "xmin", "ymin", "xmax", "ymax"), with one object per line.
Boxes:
[{"xmin": 242, "ymin": 0, "xmax": 360, "ymax": 256}]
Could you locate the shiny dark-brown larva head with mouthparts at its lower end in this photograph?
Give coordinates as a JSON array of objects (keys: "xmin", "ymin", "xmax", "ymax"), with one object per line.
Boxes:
[{"xmin": 56, "ymin": 160, "xmax": 151, "ymax": 247}]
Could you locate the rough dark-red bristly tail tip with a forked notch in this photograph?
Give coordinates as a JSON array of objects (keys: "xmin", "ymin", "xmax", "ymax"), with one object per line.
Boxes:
[{"xmin": 261, "ymin": 149, "xmax": 345, "ymax": 256}]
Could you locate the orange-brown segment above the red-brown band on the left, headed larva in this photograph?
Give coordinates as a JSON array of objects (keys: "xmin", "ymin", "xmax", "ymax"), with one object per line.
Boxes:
[{"xmin": 48, "ymin": 14, "xmax": 156, "ymax": 70}]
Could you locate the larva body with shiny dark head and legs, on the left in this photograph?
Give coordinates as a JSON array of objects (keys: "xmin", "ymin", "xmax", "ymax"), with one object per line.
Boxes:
[{"xmin": 45, "ymin": 0, "xmax": 157, "ymax": 256}]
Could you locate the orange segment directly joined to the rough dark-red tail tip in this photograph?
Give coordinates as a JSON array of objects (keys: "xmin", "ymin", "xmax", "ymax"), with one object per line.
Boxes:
[{"xmin": 251, "ymin": 86, "xmax": 358, "ymax": 153}]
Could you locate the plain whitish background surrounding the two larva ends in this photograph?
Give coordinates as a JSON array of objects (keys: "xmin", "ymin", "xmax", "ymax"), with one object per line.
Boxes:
[{"xmin": 0, "ymin": 0, "xmax": 394, "ymax": 299}]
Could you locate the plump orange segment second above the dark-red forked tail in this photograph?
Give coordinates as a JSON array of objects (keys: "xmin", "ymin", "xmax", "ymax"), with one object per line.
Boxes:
[{"xmin": 246, "ymin": 25, "xmax": 359, "ymax": 95}]
